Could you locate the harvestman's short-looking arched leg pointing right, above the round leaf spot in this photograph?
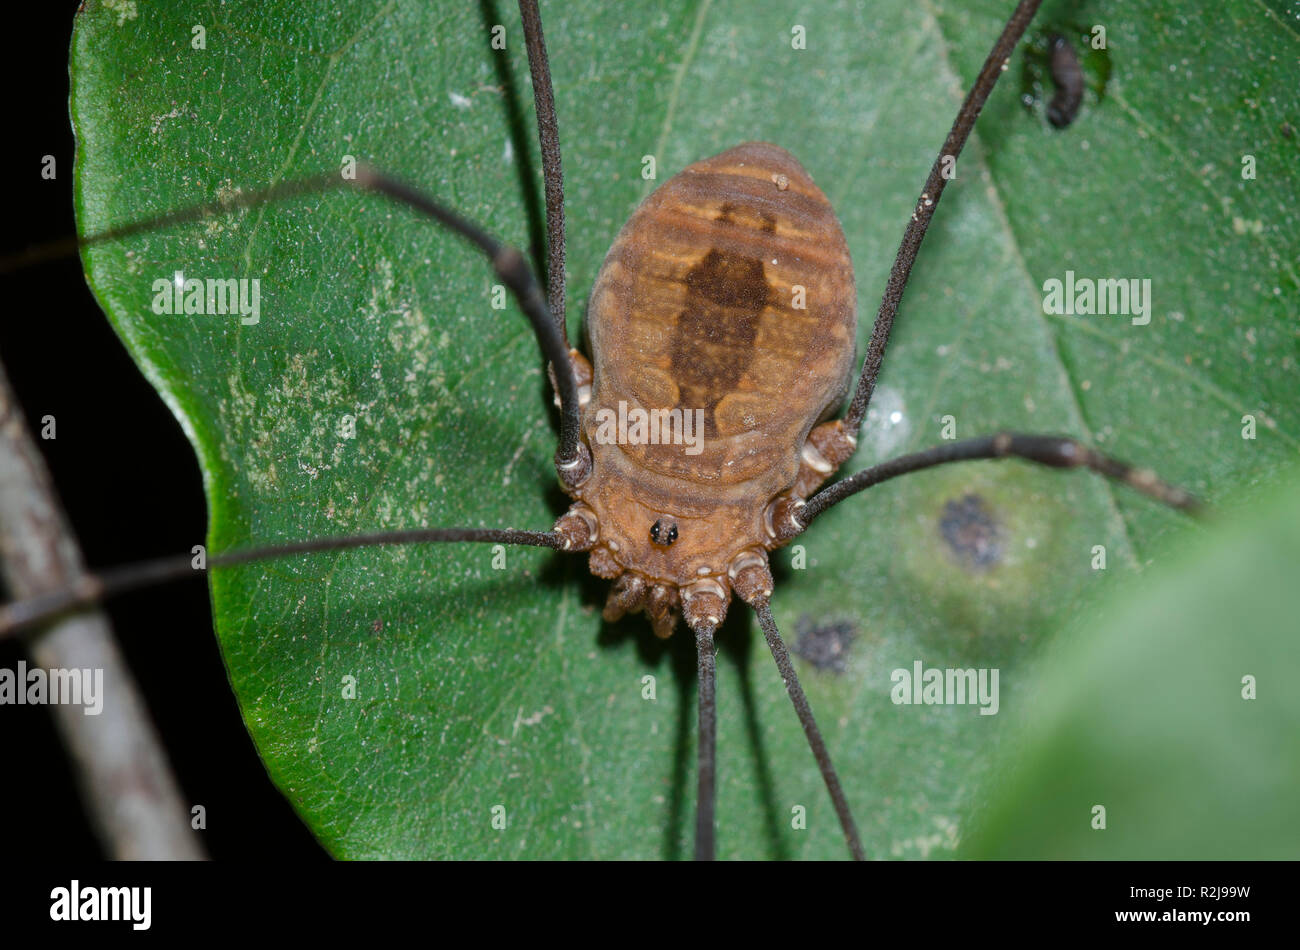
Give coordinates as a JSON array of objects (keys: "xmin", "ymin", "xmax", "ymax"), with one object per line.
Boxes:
[{"xmin": 792, "ymin": 433, "xmax": 1200, "ymax": 528}]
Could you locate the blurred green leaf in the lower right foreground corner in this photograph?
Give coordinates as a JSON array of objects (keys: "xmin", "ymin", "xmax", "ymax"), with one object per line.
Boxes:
[{"xmin": 963, "ymin": 467, "xmax": 1300, "ymax": 860}]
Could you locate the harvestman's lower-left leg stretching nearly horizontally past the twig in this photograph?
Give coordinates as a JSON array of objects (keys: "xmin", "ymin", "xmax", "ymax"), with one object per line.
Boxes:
[{"xmin": 0, "ymin": 528, "xmax": 564, "ymax": 639}]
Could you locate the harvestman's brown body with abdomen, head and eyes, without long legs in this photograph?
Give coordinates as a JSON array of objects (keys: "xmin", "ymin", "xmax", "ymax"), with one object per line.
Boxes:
[{"xmin": 555, "ymin": 143, "xmax": 858, "ymax": 637}]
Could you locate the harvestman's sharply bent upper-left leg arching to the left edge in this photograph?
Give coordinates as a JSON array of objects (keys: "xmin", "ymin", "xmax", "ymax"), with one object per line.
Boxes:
[{"xmin": 0, "ymin": 166, "xmax": 585, "ymax": 465}]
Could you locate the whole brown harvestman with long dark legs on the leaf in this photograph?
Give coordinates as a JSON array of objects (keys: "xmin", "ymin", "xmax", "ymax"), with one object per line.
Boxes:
[{"xmin": 0, "ymin": 0, "xmax": 1196, "ymax": 859}]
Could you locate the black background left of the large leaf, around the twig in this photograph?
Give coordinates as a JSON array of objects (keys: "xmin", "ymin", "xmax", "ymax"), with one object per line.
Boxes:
[{"xmin": 0, "ymin": 3, "xmax": 325, "ymax": 862}]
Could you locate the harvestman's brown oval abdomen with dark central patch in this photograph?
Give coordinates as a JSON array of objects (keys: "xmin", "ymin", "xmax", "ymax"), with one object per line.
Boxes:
[{"xmin": 586, "ymin": 142, "xmax": 857, "ymax": 498}]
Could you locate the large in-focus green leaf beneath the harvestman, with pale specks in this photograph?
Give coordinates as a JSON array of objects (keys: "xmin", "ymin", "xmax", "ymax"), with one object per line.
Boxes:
[{"xmin": 72, "ymin": 0, "xmax": 1300, "ymax": 858}]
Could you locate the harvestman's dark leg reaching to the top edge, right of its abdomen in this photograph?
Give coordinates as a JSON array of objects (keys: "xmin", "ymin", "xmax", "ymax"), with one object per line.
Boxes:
[{"xmin": 844, "ymin": 0, "xmax": 1041, "ymax": 437}]
